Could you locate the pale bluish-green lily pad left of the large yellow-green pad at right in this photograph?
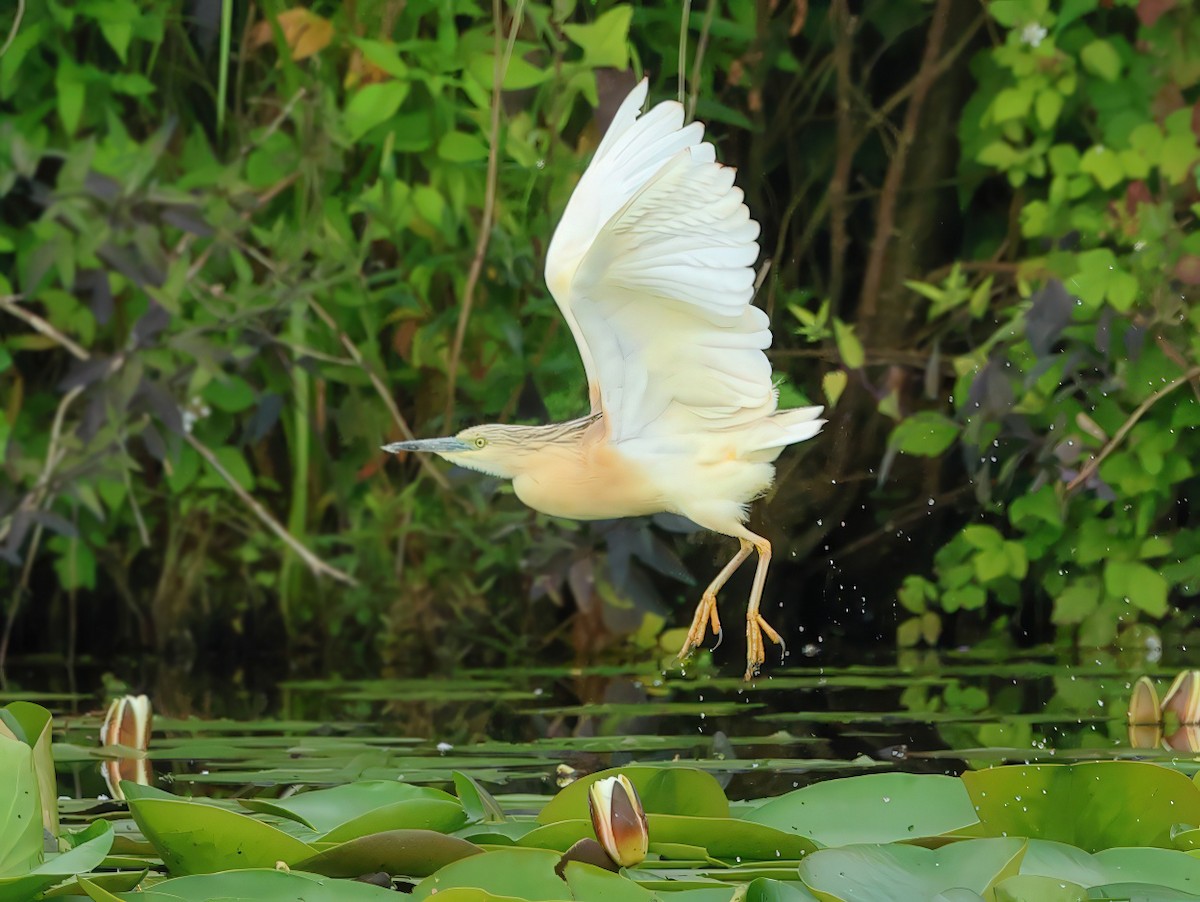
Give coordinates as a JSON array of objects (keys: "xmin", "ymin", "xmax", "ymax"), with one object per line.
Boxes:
[{"xmin": 744, "ymin": 774, "xmax": 978, "ymax": 849}]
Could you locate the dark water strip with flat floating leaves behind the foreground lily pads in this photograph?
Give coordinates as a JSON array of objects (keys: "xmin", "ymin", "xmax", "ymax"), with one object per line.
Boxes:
[{"xmin": 9, "ymin": 649, "xmax": 1192, "ymax": 800}]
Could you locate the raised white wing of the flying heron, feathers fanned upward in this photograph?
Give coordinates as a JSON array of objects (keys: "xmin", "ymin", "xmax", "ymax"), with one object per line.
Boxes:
[{"xmin": 546, "ymin": 82, "xmax": 775, "ymax": 441}]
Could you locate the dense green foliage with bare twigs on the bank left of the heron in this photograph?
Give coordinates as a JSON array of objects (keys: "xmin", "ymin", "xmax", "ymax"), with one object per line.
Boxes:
[{"xmin": 0, "ymin": 0, "xmax": 700, "ymax": 672}]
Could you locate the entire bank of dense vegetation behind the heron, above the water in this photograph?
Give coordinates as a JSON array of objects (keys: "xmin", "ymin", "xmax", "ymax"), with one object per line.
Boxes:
[{"xmin": 0, "ymin": 0, "xmax": 1200, "ymax": 674}]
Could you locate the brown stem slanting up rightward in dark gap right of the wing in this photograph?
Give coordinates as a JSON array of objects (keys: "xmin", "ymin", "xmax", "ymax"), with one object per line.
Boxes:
[{"xmin": 858, "ymin": 0, "xmax": 950, "ymax": 323}]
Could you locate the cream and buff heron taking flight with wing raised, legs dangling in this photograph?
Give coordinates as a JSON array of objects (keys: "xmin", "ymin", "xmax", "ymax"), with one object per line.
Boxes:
[{"xmin": 383, "ymin": 80, "xmax": 824, "ymax": 679}]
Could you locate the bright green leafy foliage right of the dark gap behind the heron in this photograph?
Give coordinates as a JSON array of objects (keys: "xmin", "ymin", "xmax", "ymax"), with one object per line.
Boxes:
[{"xmin": 889, "ymin": 0, "xmax": 1200, "ymax": 645}]
